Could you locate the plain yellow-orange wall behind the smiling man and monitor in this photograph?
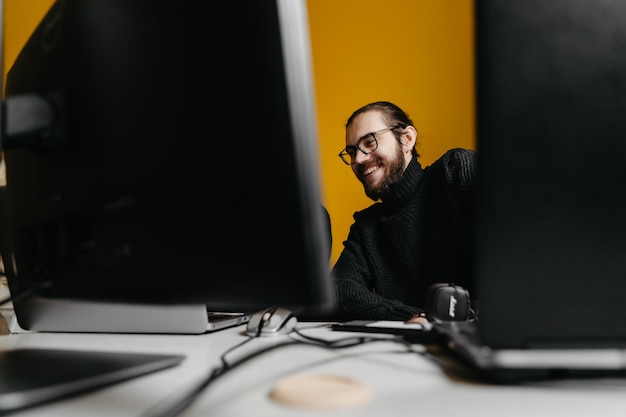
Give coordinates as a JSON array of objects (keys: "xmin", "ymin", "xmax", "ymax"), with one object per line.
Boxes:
[{"xmin": 4, "ymin": 0, "xmax": 475, "ymax": 263}]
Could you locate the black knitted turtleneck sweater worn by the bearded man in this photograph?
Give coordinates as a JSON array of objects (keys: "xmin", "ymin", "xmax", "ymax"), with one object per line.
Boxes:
[{"xmin": 333, "ymin": 148, "xmax": 476, "ymax": 320}]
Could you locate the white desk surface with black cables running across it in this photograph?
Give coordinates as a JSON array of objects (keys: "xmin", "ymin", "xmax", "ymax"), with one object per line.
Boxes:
[{"xmin": 0, "ymin": 323, "xmax": 626, "ymax": 417}]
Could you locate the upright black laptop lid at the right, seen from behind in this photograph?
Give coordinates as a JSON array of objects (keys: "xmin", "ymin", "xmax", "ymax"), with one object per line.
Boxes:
[{"xmin": 476, "ymin": 0, "xmax": 626, "ymax": 347}]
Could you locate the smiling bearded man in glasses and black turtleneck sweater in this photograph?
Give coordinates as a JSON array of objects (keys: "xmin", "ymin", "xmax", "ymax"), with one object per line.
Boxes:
[{"xmin": 333, "ymin": 101, "xmax": 476, "ymax": 322}]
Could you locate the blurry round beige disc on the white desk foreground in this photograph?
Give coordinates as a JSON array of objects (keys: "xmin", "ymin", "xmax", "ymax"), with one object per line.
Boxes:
[{"xmin": 269, "ymin": 374, "xmax": 372, "ymax": 408}]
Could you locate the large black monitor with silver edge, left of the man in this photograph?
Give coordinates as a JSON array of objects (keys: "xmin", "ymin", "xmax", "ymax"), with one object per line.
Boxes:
[{"xmin": 1, "ymin": 0, "xmax": 334, "ymax": 315}]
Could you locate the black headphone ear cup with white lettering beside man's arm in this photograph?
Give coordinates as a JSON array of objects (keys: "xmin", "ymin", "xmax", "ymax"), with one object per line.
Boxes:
[{"xmin": 426, "ymin": 283, "xmax": 473, "ymax": 321}]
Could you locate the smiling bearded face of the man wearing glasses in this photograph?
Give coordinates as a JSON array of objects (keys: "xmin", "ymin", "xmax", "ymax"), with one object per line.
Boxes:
[{"xmin": 346, "ymin": 111, "xmax": 410, "ymax": 201}]
